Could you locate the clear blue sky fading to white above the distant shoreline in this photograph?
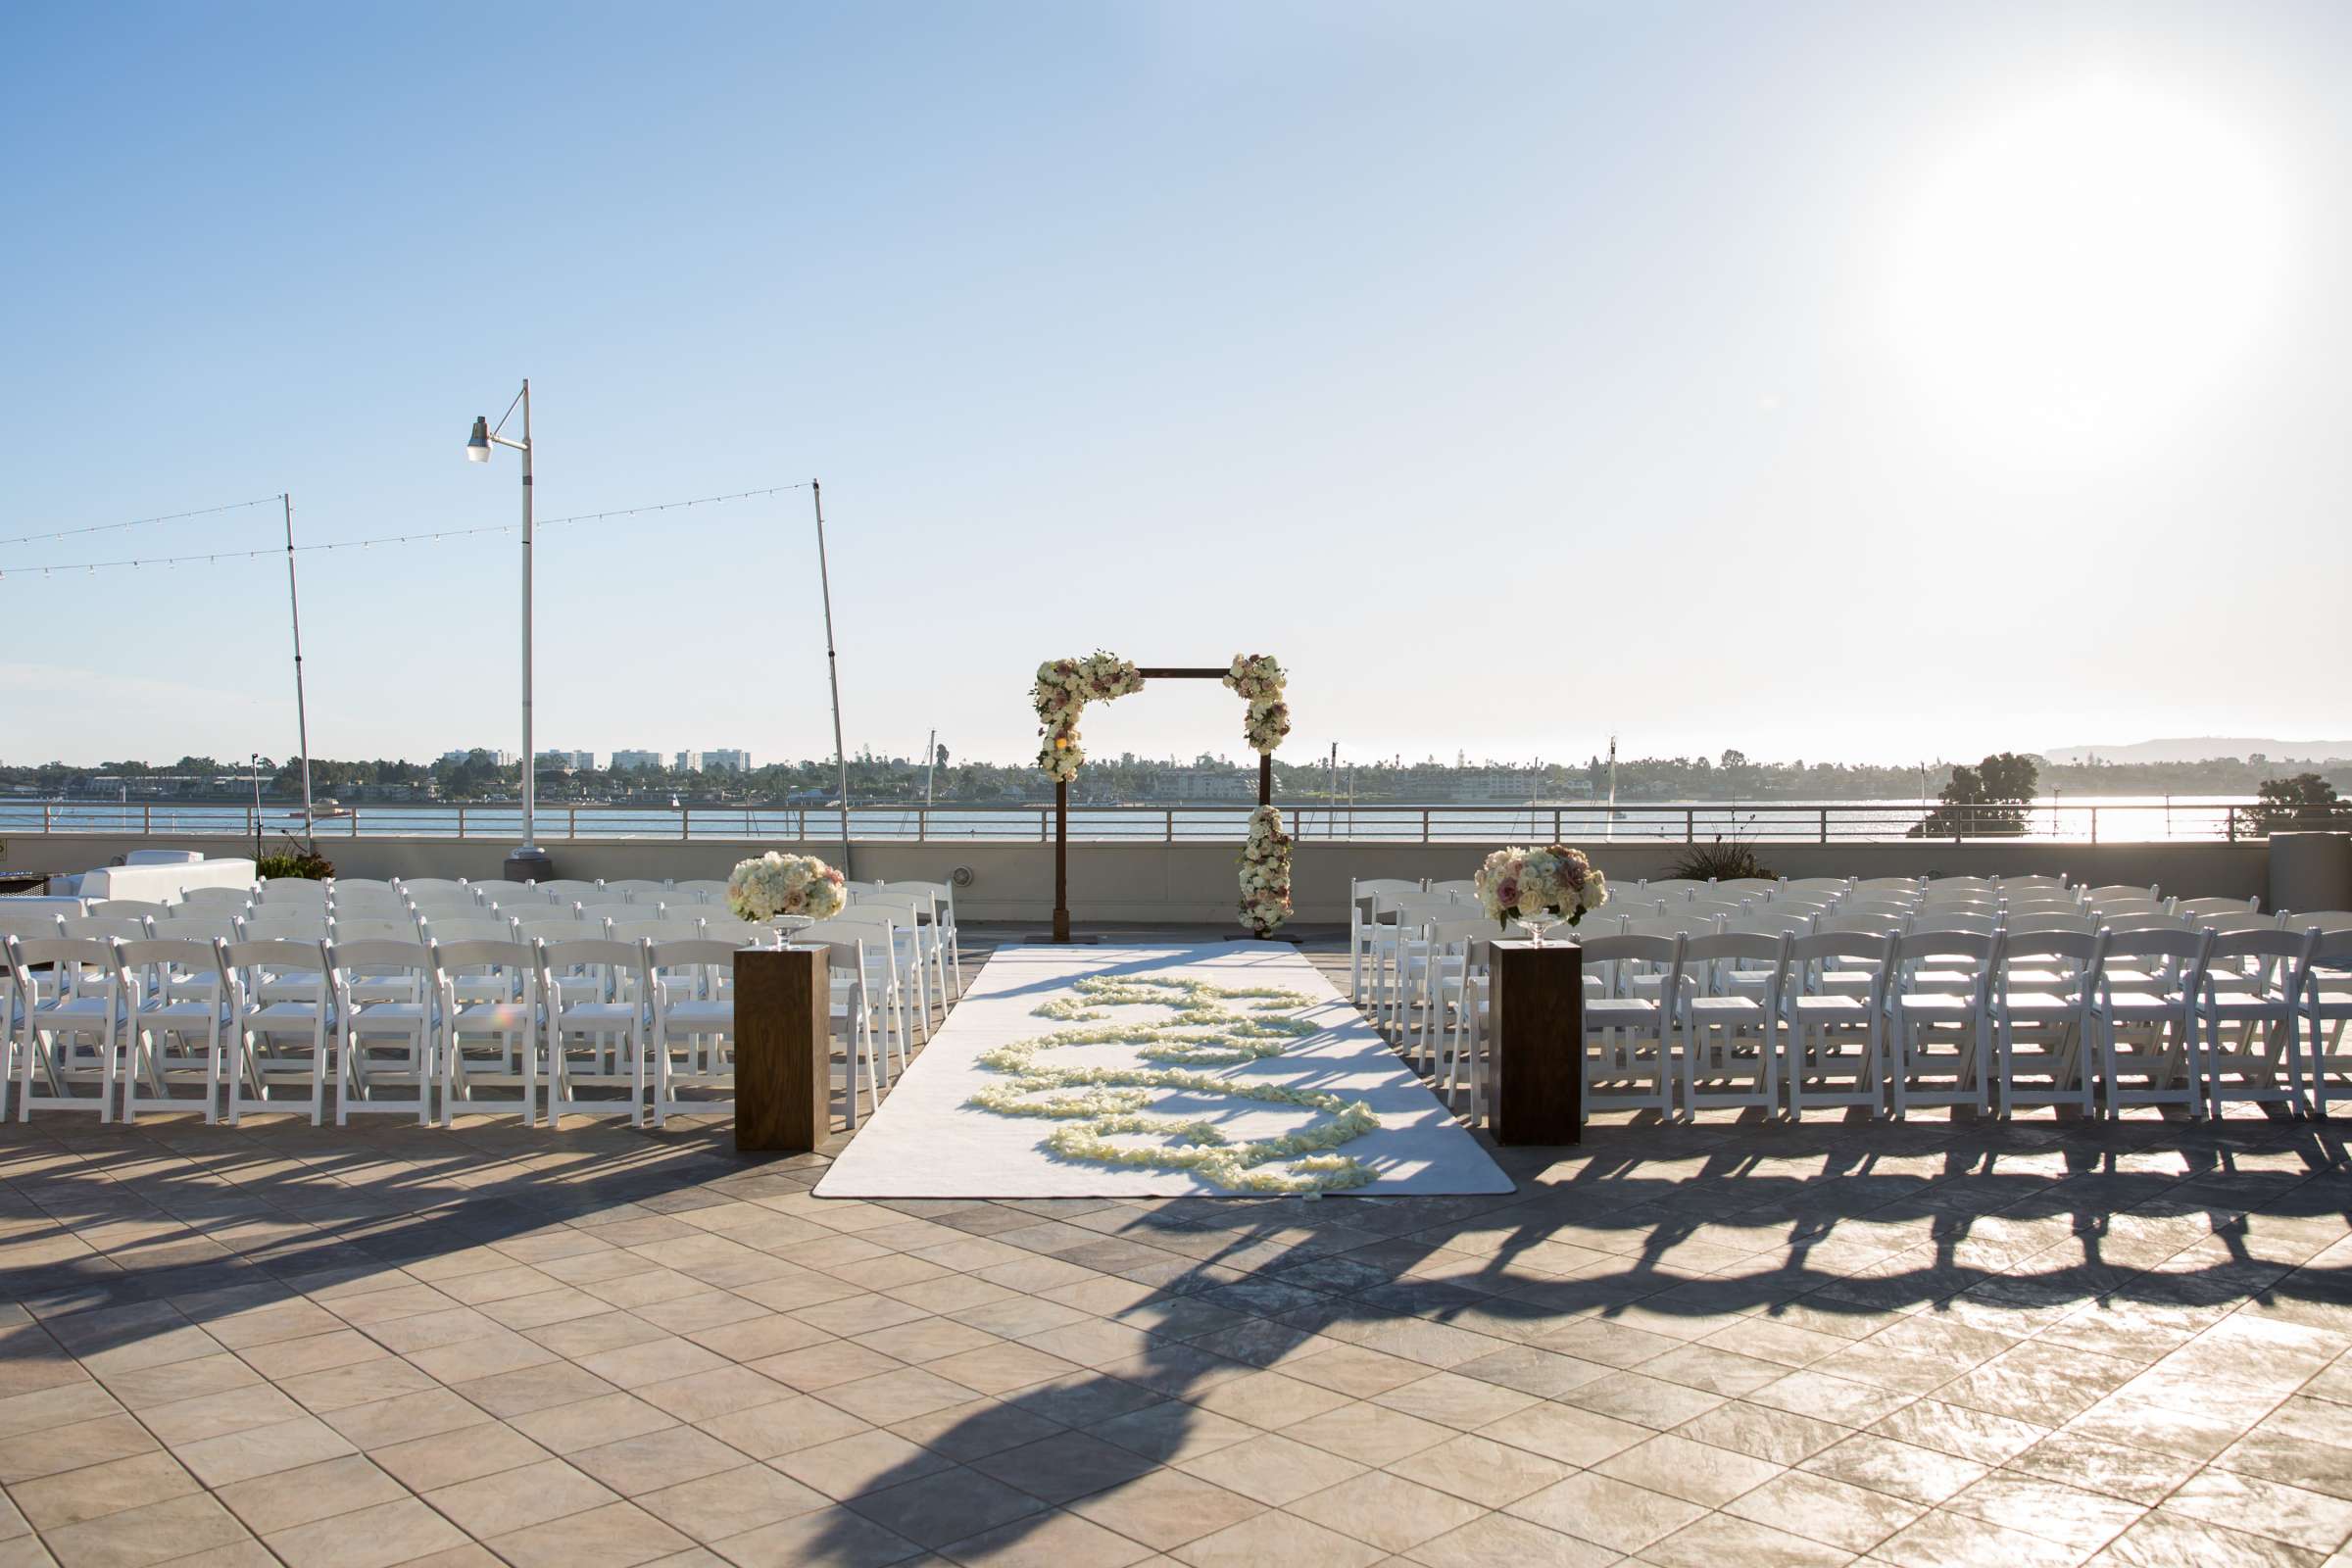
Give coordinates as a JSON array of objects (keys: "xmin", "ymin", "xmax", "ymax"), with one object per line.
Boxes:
[{"xmin": 0, "ymin": 0, "xmax": 2352, "ymax": 764}]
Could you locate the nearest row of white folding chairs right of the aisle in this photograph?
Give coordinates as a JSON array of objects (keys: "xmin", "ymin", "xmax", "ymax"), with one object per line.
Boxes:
[{"xmin": 1440, "ymin": 926, "xmax": 2352, "ymax": 1116}]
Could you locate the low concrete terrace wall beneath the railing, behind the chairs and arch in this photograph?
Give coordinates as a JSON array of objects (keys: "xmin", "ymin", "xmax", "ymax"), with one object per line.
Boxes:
[{"xmin": 0, "ymin": 835, "xmax": 2277, "ymax": 921}]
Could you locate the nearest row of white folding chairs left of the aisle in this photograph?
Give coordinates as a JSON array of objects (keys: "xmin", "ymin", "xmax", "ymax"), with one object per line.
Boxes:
[{"xmin": 0, "ymin": 938, "xmax": 880, "ymax": 1124}]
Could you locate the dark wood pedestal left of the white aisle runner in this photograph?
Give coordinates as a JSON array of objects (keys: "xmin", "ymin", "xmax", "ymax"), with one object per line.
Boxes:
[{"xmin": 736, "ymin": 948, "xmax": 833, "ymax": 1154}]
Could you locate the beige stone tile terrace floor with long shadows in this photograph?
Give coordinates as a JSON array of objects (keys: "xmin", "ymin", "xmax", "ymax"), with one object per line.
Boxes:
[{"xmin": 0, "ymin": 955, "xmax": 2352, "ymax": 1568}]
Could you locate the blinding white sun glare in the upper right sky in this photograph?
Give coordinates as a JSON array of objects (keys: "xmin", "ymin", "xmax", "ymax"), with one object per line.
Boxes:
[{"xmin": 1886, "ymin": 77, "xmax": 2286, "ymax": 454}]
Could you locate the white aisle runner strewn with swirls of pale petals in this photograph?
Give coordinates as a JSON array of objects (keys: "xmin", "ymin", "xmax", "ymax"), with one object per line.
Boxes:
[{"xmin": 816, "ymin": 943, "xmax": 1512, "ymax": 1199}]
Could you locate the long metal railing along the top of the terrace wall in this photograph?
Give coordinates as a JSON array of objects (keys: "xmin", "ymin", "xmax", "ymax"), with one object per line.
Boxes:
[{"xmin": 0, "ymin": 797, "xmax": 2314, "ymax": 844}]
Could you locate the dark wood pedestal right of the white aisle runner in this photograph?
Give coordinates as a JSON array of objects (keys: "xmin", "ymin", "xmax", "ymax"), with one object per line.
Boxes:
[{"xmin": 1487, "ymin": 943, "xmax": 1586, "ymax": 1145}]
